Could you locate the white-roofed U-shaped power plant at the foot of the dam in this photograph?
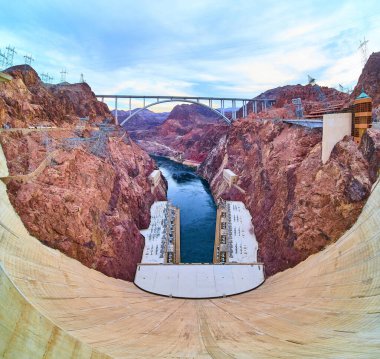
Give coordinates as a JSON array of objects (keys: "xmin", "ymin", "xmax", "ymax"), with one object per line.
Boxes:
[{"xmin": 134, "ymin": 170, "xmax": 265, "ymax": 299}]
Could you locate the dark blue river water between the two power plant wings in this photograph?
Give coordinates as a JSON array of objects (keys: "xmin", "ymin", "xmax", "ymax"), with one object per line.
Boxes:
[{"xmin": 152, "ymin": 156, "xmax": 216, "ymax": 263}]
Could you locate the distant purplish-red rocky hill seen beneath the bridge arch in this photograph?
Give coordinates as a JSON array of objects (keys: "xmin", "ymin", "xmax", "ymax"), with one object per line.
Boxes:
[{"xmin": 131, "ymin": 104, "xmax": 228, "ymax": 163}]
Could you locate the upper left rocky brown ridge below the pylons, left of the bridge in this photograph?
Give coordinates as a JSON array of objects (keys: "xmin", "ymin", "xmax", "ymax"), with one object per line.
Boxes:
[{"xmin": 0, "ymin": 65, "xmax": 112, "ymax": 127}]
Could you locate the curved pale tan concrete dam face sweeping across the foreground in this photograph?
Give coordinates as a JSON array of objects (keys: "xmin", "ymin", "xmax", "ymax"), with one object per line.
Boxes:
[{"xmin": 0, "ymin": 168, "xmax": 380, "ymax": 359}]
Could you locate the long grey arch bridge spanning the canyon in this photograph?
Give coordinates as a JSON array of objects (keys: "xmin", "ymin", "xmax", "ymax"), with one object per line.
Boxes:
[{"xmin": 96, "ymin": 95, "xmax": 275, "ymax": 125}]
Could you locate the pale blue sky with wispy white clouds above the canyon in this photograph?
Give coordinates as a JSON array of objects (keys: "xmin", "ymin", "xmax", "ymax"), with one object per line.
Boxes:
[{"xmin": 0, "ymin": 0, "xmax": 380, "ymax": 111}]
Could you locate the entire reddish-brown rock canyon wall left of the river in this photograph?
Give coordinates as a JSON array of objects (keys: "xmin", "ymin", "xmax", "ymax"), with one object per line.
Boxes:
[{"xmin": 0, "ymin": 67, "xmax": 166, "ymax": 280}]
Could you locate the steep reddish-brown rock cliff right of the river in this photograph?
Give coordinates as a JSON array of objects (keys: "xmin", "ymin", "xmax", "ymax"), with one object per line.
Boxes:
[{"xmin": 199, "ymin": 120, "xmax": 380, "ymax": 275}]
